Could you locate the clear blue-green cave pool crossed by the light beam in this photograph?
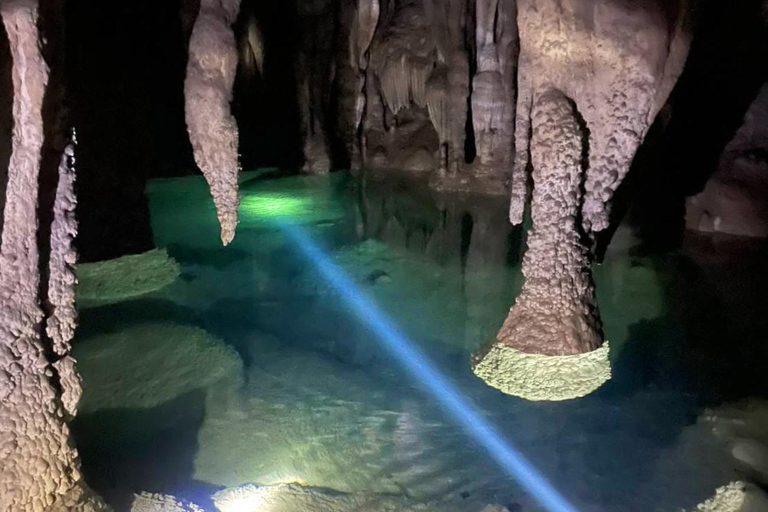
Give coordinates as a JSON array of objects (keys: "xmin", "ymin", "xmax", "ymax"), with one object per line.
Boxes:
[{"xmin": 73, "ymin": 171, "xmax": 768, "ymax": 512}]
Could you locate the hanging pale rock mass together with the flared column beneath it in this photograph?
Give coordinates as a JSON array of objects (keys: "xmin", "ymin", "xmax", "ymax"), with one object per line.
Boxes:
[{"xmin": 474, "ymin": 0, "xmax": 689, "ymax": 400}]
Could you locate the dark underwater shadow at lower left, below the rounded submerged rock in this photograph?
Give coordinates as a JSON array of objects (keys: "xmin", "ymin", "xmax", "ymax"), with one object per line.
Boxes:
[{"xmin": 72, "ymin": 390, "xmax": 210, "ymax": 511}]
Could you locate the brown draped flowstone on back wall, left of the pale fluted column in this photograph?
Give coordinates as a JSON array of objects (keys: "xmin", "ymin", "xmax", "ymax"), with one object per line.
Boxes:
[{"xmin": 338, "ymin": 0, "xmax": 469, "ymax": 175}]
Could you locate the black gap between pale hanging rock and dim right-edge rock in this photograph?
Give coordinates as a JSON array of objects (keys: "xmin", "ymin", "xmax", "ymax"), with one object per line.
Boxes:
[{"xmin": 601, "ymin": 0, "xmax": 768, "ymax": 255}]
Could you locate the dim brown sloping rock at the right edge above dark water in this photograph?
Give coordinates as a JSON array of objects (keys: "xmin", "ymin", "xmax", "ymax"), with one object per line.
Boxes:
[{"xmin": 686, "ymin": 85, "xmax": 768, "ymax": 238}]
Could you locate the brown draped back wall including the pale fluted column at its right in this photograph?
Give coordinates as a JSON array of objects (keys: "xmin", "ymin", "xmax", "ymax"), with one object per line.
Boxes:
[{"xmin": 336, "ymin": 0, "xmax": 517, "ymax": 195}]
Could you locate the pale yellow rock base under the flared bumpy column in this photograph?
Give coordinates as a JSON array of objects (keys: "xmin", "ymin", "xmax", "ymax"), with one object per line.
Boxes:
[{"xmin": 472, "ymin": 341, "xmax": 611, "ymax": 401}]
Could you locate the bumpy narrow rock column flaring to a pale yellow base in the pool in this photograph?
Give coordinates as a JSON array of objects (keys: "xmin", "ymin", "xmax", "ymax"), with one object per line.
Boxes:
[{"xmin": 474, "ymin": 90, "xmax": 610, "ymax": 400}]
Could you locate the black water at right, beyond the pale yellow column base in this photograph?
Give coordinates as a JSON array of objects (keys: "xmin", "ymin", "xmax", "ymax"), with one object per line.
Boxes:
[{"xmin": 606, "ymin": 234, "xmax": 768, "ymax": 406}]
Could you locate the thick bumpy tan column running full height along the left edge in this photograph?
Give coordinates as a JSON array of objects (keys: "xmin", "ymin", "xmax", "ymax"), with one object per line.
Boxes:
[{"xmin": 0, "ymin": 0, "xmax": 105, "ymax": 512}]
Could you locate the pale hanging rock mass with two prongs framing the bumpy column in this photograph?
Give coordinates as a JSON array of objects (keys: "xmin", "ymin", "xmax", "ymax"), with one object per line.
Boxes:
[{"xmin": 510, "ymin": 0, "xmax": 691, "ymax": 232}]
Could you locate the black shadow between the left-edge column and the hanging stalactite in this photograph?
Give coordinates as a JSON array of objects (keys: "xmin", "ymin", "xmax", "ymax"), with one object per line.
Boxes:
[{"xmin": 66, "ymin": 0, "xmax": 196, "ymax": 261}]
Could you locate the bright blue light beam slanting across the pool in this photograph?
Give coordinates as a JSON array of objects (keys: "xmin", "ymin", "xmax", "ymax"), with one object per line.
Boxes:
[{"xmin": 281, "ymin": 223, "xmax": 578, "ymax": 512}]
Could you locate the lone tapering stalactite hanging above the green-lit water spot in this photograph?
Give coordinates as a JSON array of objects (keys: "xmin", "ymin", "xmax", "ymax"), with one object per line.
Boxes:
[{"xmin": 184, "ymin": 0, "xmax": 240, "ymax": 245}]
